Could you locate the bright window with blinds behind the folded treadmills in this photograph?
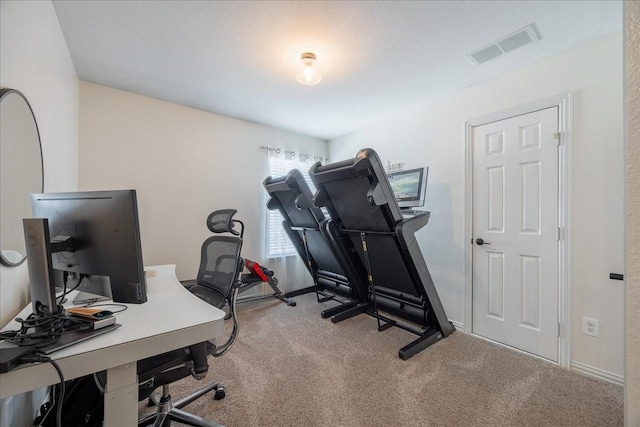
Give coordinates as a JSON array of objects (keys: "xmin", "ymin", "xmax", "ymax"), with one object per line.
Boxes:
[{"xmin": 267, "ymin": 148, "xmax": 326, "ymax": 258}]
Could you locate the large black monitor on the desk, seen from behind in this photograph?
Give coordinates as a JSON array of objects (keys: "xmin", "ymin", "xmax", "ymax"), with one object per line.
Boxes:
[{"xmin": 30, "ymin": 190, "xmax": 147, "ymax": 304}]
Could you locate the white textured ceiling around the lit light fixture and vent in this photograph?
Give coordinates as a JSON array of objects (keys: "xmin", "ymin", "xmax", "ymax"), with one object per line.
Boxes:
[{"xmin": 54, "ymin": 0, "xmax": 622, "ymax": 140}]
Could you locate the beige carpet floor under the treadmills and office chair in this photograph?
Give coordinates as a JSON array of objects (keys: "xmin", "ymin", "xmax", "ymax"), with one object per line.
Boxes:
[{"xmin": 140, "ymin": 295, "xmax": 623, "ymax": 427}]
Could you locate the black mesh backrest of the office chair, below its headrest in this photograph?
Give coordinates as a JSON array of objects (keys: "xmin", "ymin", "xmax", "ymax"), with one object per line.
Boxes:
[{"xmin": 197, "ymin": 236, "xmax": 243, "ymax": 297}]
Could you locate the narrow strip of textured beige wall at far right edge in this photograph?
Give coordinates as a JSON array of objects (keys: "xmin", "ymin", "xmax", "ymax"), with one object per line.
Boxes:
[{"xmin": 624, "ymin": 2, "xmax": 640, "ymax": 427}]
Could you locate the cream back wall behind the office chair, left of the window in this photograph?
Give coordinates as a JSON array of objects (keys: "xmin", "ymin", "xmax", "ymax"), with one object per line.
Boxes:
[{"xmin": 80, "ymin": 82, "xmax": 327, "ymax": 291}]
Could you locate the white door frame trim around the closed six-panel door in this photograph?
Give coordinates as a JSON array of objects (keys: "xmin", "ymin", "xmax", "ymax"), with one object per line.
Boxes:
[{"xmin": 464, "ymin": 93, "xmax": 572, "ymax": 369}]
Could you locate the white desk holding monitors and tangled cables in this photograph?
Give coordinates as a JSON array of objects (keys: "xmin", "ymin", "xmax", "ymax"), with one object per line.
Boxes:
[{"xmin": 0, "ymin": 265, "xmax": 224, "ymax": 427}]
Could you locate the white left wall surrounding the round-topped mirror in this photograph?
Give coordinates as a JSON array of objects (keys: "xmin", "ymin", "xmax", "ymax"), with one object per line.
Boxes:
[{"xmin": 0, "ymin": 1, "xmax": 78, "ymax": 325}]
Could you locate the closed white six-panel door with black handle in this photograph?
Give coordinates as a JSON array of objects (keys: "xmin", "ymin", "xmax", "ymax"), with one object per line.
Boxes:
[{"xmin": 472, "ymin": 107, "xmax": 559, "ymax": 361}]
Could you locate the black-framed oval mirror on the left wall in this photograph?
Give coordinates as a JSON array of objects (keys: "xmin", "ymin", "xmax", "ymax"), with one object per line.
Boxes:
[{"xmin": 0, "ymin": 89, "xmax": 44, "ymax": 267}]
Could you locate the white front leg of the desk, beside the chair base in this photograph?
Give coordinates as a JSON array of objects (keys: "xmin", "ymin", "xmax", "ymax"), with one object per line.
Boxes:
[{"xmin": 103, "ymin": 363, "xmax": 138, "ymax": 427}]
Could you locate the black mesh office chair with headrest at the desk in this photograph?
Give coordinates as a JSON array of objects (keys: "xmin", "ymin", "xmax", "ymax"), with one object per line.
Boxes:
[{"xmin": 138, "ymin": 209, "xmax": 244, "ymax": 427}]
